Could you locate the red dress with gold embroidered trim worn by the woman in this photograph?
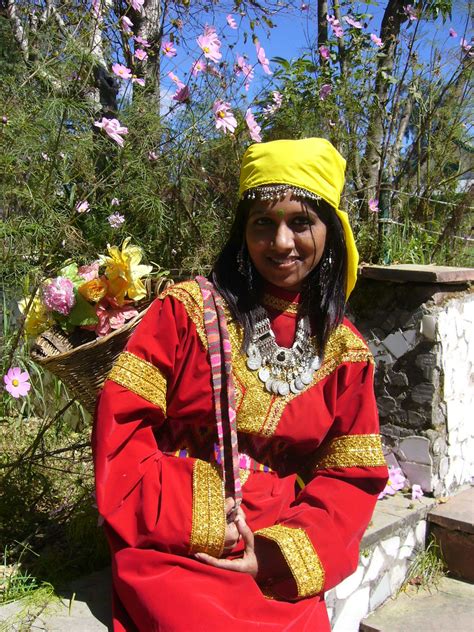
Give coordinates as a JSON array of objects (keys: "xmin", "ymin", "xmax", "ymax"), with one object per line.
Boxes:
[{"xmin": 93, "ymin": 281, "xmax": 387, "ymax": 632}]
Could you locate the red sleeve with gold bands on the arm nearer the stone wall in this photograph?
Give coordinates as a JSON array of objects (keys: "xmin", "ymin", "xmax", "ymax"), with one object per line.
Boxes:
[{"xmin": 256, "ymin": 361, "xmax": 387, "ymax": 599}]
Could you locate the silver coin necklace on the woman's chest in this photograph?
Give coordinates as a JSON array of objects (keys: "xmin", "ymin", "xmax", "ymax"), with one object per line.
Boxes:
[{"xmin": 247, "ymin": 307, "xmax": 321, "ymax": 397}]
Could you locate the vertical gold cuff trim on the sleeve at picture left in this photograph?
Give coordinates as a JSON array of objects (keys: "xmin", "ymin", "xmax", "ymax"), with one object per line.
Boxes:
[{"xmin": 190, "ymin": 459, "xmax": 225, "ymax": 557}]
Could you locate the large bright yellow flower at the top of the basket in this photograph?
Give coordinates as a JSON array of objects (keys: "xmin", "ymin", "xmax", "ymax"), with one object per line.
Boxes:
[{"xmin": 100, "ymin": 237, "xmax": 152, "ymax": 305}]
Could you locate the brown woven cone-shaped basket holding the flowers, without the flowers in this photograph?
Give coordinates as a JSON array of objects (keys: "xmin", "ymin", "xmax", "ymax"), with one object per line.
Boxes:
[{"xmin": 31, "ymin": 278, "xmax": 173, "ymax": 413}]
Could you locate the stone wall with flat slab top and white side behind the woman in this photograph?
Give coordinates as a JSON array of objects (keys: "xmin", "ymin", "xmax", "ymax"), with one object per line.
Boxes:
[{"xmin": 350, "ymin": 266, "xmax": 474, "ymax": 496}]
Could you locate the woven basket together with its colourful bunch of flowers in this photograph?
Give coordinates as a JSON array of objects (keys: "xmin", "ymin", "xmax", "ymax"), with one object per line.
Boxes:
[{"xmin": 25, "ymin": 238, "xmax": 170, "ymax": 412}]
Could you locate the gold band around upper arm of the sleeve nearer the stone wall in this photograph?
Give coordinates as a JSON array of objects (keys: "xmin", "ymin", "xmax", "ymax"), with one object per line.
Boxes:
[{"xmin": 315, "ymin": 434, "xmax": 386, "ymax": 469}]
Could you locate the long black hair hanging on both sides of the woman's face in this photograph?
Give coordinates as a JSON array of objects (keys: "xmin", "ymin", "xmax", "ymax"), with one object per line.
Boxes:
[{"xmin": 210, "ymin": 198, "xmax": 347, "ymax": 355}]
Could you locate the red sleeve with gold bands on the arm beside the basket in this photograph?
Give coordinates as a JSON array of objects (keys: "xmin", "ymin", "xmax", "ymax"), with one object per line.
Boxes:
[{"xmin": 92, "ymin": 296, "xmax": 225, "ymax": 555}]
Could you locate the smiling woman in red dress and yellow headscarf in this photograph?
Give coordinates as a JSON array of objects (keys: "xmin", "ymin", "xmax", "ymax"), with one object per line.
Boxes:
[{"xmin": 93, "ymin": 138, "xmax": 387, "ymax": 632}]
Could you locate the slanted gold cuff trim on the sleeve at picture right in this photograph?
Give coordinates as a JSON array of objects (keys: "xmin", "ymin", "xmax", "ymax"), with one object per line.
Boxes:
[{"xmin": 255, "ymin": 524, "xmax": 324, "ymax": 597}]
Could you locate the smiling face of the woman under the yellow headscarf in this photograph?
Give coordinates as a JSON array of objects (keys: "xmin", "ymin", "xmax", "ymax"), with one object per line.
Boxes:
[{"xmin": 245, "ymin": 193, "xmax": 326, "ymax": 292}]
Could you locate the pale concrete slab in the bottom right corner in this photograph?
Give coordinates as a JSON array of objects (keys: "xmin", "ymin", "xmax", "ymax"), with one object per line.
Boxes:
[{"xmin": 359, "ymin": 577, "xmax": 474, "ymax": 632}]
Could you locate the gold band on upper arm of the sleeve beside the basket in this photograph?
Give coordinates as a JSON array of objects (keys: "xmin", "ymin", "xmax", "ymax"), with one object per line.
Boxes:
[{"xmin": 107, "ymin": 351, "xmax": 166, "ymax": 415}]
